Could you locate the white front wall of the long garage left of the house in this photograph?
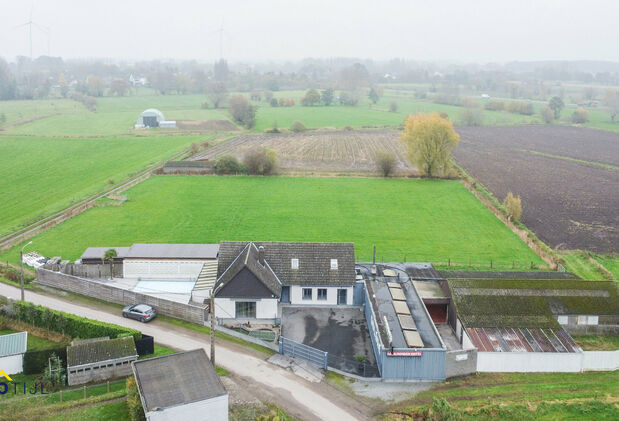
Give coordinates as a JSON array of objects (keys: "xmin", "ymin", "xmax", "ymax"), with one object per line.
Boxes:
[{"xmin": 123, "ymin": 259, "xmax": 209, "ymax": 280}]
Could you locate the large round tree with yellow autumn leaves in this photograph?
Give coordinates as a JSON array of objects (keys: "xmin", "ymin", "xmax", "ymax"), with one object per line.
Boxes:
[{"xmin": 401, "ymin": 113, "xmax": 460, "ymax": 177}]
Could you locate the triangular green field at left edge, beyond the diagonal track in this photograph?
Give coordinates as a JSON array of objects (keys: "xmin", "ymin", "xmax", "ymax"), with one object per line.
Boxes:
[{"xmin": 0, "ymin": 136, "xmax": 211, "ymax": 235}]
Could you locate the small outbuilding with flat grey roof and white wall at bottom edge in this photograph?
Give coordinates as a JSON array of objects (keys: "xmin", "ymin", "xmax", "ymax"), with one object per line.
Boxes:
[{"xmin": 133, "ymin": 349, "xmax": 228, "ymax": 421}]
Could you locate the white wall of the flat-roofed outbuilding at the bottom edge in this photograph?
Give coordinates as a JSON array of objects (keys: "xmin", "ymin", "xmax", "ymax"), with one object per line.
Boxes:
[{"xmin": 146, "ymin": 395, "xmax": 228, "ymax": 421}]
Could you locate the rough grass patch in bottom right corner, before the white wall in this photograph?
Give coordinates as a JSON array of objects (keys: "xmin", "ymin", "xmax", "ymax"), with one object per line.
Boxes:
[{"xmin": 383, "ymin": 372, "xmax": 619, "ymax": 420}]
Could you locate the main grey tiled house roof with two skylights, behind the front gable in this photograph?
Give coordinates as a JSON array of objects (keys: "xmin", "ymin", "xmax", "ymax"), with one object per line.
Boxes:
[{"xmin": 217, "ymin": 241, "xmax": 355, "ymax": 286}]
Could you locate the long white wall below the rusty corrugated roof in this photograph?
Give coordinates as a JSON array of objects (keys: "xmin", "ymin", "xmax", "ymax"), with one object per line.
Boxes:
[{"xmin": 477, "ymin": 352, "xmax": 583, "ymax": 373}]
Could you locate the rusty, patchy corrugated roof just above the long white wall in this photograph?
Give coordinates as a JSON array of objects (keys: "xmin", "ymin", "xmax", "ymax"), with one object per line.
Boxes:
[{"xmin": 466, "ymin": 327, "xmax": 582, "ymax": 352}]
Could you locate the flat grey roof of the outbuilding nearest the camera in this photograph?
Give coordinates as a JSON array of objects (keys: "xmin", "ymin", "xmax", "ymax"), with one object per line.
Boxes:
[{"xmin": 133, "ymin": 349, "xmax": 227, "ymax": 412}]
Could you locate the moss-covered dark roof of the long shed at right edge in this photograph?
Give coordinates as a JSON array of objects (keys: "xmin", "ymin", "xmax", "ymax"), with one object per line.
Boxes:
[{"xmin": 449, "ymin": 279, "xmax": 619, "ymax": 329}]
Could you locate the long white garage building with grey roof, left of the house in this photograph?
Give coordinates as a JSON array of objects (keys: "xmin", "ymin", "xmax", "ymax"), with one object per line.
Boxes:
[{"xmin": 123, "ymin": 244, "xmax": 219, "ymax": 281}]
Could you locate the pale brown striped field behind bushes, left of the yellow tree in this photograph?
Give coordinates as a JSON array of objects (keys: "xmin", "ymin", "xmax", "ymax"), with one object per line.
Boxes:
[{"xmin": 189, "ymin": 130, "xmax": 415, "ymax": 174}]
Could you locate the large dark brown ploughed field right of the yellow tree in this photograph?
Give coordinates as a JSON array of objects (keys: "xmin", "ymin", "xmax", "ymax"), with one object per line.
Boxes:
[{"xmin": 454, "ymin": 126, "xmax": 619, "ymax": 253}]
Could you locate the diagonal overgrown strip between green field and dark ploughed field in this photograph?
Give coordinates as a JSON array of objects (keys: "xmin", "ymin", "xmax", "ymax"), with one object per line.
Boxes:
[{"xmin": 452, "ymin": 158, "xmax": 559, "ymax": 270}]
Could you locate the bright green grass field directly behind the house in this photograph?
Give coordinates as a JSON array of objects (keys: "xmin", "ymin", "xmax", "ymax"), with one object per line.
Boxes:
[{"xmin": 0, "ymin": 176, "xmax": 542, "ymax": 266}]
